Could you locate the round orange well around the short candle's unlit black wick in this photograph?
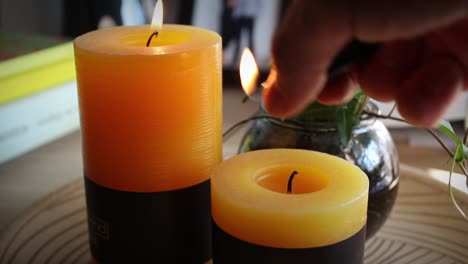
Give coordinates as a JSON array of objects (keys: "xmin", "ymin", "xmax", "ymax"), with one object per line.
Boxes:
[{"xmin": 254, "ymin": 165, "xmax": 330, "ymax": 194}]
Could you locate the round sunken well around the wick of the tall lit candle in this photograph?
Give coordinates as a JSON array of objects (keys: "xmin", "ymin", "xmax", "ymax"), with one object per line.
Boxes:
[{"xmin": 120, "ymin": 29, "xmax": 192, "ymax": 47}]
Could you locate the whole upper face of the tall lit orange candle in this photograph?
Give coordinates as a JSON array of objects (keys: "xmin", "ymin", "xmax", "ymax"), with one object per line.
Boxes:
[{"xmin": 74, "ymin": 24, "xmax": 221, "ymax": 55}]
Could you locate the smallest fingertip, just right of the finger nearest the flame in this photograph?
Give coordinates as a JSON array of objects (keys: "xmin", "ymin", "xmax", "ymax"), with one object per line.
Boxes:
[{"xmin": 317, "ymin": 74, "xmax": 358, "ymax": 105}]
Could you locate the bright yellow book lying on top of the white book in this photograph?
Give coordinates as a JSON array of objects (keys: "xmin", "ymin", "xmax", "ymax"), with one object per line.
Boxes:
[{"xmin": 0, "ymin": 42, "xmax": 75, "ymax": 105}]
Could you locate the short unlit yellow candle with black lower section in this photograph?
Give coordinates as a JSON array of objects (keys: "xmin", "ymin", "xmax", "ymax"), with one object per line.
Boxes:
[{"xmin": 211, "ymin": 149, "xmax": 369, "ymax": 263}]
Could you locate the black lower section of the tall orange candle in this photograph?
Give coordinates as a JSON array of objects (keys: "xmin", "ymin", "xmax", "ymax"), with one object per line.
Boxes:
[{"xmin": 84, "ymin": 177, "xmax": 212, "ymax": 263}]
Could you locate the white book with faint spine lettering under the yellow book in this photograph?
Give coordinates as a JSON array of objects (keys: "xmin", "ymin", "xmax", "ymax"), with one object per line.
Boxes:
[{"xmin": 0, "ymin": 80, "xmax": 80, "ymax": 164}]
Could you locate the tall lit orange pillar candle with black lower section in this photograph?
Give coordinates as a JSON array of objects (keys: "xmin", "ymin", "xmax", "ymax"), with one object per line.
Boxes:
[{"xmin": 74, "ymin": 25, "xmax": 222, "ymax": 263}]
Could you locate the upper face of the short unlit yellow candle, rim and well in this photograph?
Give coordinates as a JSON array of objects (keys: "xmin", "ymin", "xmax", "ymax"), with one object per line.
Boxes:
[{"xmin": 212, "ymin": 149, "xmax": 369, "ymax": 213}]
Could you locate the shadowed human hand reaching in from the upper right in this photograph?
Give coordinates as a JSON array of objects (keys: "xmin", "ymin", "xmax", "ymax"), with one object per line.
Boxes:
[{"xmin": 263, "ymin": 0, "xmax": 468, "ymax": 127}]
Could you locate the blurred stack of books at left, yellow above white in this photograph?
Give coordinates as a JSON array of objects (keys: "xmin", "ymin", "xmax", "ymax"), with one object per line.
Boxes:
[{"xmin": 0, "ymin": 33, "xmax": 79, "ymax": 164}]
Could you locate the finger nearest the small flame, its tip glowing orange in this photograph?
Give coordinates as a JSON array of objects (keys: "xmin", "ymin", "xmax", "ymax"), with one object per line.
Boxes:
[{"xmin": 263, "ymin": 1, "xmax": 351, "ymax": 117}]
